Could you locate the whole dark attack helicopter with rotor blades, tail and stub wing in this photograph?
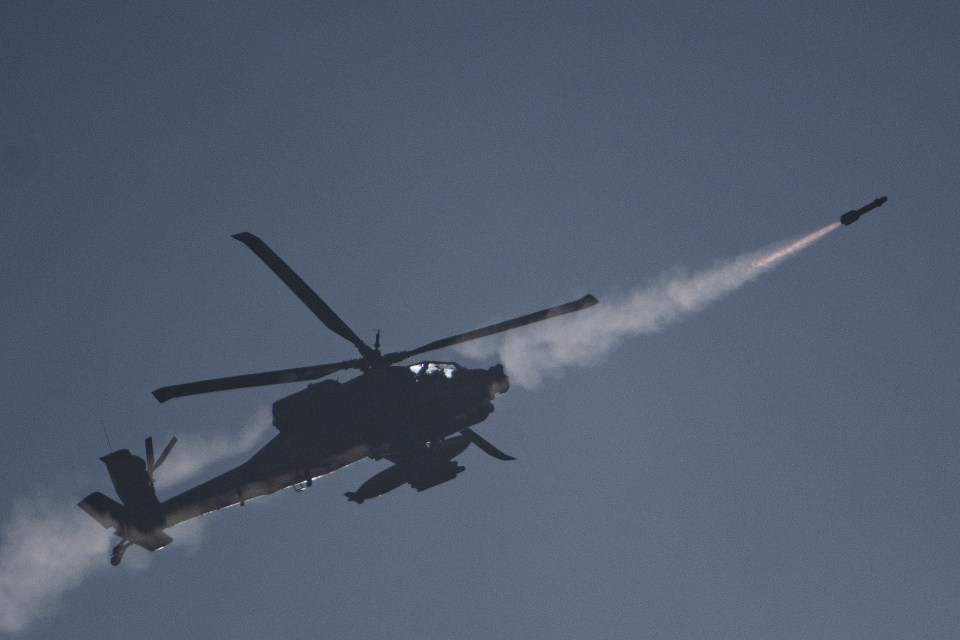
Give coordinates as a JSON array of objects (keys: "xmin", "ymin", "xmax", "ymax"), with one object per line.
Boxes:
[{"xmin": 78, "ymin": 233, "xmax": 597, "ymax": 565}]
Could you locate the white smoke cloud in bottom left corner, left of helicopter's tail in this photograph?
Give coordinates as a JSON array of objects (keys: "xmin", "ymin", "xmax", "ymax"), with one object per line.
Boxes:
[{"xmin": 0, "ymin": 497, "xmax": 110, "ymax": 635}]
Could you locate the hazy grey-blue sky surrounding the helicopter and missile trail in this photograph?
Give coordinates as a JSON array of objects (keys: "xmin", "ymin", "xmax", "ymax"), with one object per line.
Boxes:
[{"xmin": 0, "ymin": 2, "xmax": 960, "ymax": 639}]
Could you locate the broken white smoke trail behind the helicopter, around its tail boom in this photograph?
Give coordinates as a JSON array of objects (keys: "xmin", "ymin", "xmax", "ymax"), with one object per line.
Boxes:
[{"xmin": 0, "ymin": 409, "xmax": 270, "ymax": 636}]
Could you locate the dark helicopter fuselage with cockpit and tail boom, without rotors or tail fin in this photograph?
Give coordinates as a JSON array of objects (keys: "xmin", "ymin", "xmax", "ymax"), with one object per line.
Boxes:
[{"xmin": 161, "ymin": 362, "xmax": 510, "ymax": 527}]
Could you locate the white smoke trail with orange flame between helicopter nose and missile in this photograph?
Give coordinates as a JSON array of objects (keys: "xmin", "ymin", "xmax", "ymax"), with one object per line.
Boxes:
[{"xmin": 476, "ymin": 222, "xmax": 840, "ymax": 388}]
